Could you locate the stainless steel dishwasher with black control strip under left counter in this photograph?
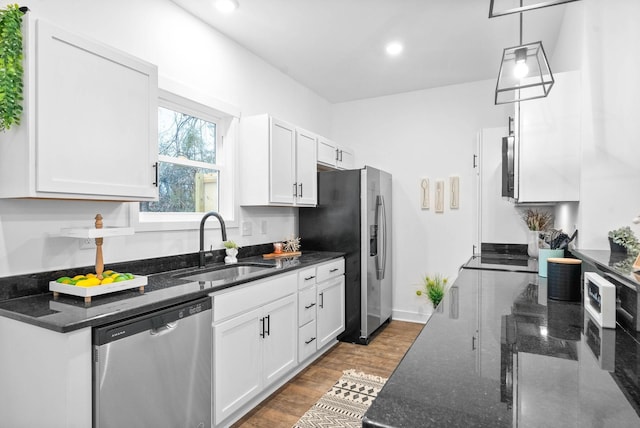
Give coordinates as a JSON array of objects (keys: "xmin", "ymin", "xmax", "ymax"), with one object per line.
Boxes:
[{"xmin": 93, "ymin": 297, "xmax": 212, "ymax": 428}]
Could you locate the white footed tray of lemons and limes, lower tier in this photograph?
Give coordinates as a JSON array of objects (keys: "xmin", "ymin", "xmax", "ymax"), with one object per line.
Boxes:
[{"xmin": 49, "ymin": 270, "xmax": 147, "ymax": 303}]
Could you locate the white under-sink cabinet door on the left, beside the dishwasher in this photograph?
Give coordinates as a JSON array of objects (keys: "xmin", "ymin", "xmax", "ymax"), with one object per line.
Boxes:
[{"xmin": 213, "ymin": 308, "xmax": 263, "ymax": 424}]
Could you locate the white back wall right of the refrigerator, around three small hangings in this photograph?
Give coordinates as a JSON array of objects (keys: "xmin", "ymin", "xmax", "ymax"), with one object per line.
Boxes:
[{"xmin": 332, "ymin": 80, "xmax": 509, "ymax": 319}]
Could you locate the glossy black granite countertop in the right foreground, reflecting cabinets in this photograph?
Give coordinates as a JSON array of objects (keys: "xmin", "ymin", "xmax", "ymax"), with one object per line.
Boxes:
[{"xmin": 363, "ymin": 269, "xmax": 640, "ymax": 428}]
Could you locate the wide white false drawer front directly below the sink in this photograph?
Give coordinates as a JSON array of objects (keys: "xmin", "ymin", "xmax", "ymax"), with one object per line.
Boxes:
[{"xmin": 212, "ymin": 273, "xmax": 297, "ymax": 323}]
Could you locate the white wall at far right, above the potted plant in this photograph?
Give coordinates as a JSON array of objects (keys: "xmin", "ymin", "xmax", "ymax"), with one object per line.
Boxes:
[{"xmin": 579, "ymin": 0, "xmax": 640, "ymax": 249}]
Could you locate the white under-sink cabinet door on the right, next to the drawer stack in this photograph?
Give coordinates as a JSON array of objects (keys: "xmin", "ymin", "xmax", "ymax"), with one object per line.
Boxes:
[{"xmin": 262, "ymin": 294, "xmax": 298, "ymax": 386}]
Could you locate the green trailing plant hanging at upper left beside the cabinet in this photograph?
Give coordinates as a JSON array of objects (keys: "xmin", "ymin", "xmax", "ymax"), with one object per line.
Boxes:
[{"xmin": 0, "ymin": 4, "xmax": 26, "ymax": 131}]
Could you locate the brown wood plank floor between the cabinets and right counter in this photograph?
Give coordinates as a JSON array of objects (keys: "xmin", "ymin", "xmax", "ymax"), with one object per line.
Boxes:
[{"xmin": 233, "ymin": 321, "xmax": 423, "ymax": 428}]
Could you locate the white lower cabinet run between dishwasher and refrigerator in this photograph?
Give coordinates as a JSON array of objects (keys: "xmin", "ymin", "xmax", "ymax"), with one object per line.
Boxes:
[{"xmin": 211, "ymin": 258, "xmax": 345, "ymax": 427}]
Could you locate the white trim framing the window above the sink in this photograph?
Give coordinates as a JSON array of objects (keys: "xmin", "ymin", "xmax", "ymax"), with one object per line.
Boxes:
[{"xmin": 129, "ymin": 78, "xmax": 240, "ymax": 232}]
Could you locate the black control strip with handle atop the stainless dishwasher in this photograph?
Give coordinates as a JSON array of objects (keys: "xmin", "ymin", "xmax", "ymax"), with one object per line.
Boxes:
[{"xmin": 93, "ymin": 297, "xmax": 211, "ymax": 346}]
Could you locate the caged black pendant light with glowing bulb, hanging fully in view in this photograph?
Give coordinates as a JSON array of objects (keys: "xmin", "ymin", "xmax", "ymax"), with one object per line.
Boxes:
[{"xmin": 491, "ymin": 0, "xmax": 554, "ymax": 105}]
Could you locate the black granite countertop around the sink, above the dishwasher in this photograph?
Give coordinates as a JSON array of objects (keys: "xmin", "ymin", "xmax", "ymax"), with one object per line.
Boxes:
[{"xmin": 0, "ymin": 251, "xmax": 344, "ymax": 333}]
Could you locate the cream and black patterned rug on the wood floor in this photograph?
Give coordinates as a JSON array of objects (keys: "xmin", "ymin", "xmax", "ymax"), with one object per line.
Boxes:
[{"xmin": 293, "ymin": 370, "xmax": 387, "ymax": 428}]
